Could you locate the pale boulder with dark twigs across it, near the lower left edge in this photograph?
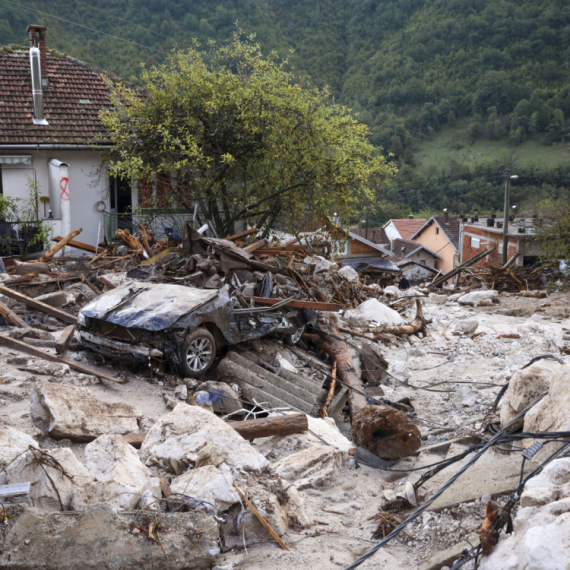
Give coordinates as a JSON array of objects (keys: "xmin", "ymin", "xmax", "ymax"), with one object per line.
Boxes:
[{"xmin": 6, "ymin": 447, "xmax": 91, "ymax": 511}]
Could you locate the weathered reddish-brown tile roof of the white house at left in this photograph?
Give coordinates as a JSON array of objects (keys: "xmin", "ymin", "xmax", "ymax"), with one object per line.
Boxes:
[{"xmin": 0, "ymin": 48, "xmax": 123, "ymax": 145}]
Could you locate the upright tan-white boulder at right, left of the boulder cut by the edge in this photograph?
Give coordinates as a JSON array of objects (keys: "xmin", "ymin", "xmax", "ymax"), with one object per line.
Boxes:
[{"xmin": 501, "ymin": 359, "xmax": 561, "ymax": 427}]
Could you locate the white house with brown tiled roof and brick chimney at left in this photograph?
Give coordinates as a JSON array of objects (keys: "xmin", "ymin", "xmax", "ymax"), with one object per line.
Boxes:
[{"xmin": 0, "ymin": 25, "xmax": 189, "ymax": 251}]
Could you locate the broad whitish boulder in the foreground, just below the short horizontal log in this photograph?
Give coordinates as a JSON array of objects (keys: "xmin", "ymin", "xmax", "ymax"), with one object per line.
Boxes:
[{"xmin": 140, "ymin": 403, "xmax": 269, "ymax": 469}]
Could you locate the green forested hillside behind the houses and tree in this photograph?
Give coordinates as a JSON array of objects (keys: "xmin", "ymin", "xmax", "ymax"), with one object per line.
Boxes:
[{"xmin": 0, "ymin": 0, "xmax": 570, "ymax": 215}]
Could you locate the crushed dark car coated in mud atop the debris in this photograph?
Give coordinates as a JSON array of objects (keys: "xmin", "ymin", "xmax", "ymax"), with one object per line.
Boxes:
[{"xmin": 76, "ymin": 281, "xmax": 316, "ymax": 377}]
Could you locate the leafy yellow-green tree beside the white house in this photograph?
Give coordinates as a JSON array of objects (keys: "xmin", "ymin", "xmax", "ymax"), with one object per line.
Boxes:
[{"xmin": 101, "ymin": 32, "xmax": 393, "ymax": 235}]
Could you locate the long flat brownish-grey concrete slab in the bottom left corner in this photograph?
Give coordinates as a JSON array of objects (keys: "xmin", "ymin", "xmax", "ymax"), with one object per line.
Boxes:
[{"xmin": 0, "ymin": 503, "xmax": 220, "ymax": 570}]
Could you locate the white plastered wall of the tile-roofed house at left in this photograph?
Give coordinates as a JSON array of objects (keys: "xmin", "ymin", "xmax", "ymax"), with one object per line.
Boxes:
[{"xmin": 0, "ymin": 150, "xmax": 109, "ymax": 253}]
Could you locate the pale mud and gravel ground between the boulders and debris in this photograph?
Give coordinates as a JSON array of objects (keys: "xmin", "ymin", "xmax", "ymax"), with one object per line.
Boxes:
[{"xmin": 0, "ymin": 292, "xmax": 570, "ymax": 570}]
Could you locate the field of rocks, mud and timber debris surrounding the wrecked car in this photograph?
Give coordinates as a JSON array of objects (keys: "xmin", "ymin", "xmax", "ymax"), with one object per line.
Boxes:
[{"xmin": 0, "ymin": 228, "xmax": 570, "ymax": 570}]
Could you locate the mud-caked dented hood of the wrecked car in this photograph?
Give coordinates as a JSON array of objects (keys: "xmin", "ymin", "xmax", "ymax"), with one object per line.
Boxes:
[{"xmin": 81, "ymin": 281, "xmax": 221, "ymax": 331}]
